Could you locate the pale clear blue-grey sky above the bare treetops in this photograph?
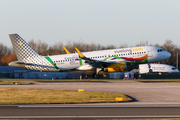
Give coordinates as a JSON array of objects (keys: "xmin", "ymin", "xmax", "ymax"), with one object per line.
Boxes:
[{"xmin": 0, "ymin": 0, "xmax": 180, "ymax": 47}]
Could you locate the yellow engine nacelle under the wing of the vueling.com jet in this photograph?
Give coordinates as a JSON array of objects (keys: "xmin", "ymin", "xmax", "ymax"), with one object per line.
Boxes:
[{"xmin": 104, "ymin": 62, "xmax": 126, "ymax": 72}]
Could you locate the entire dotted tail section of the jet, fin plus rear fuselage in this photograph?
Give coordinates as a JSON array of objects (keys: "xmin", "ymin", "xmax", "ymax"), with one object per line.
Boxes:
[{"xmin": 9, "ymin": 34, "xmax": 60, "ymax": 72}]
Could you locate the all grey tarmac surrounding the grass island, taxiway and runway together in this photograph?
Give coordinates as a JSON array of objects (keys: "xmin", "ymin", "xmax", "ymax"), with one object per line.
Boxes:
[{"xmin": 0, "ymin": 81, "xmax": 180, "ymax": 119}]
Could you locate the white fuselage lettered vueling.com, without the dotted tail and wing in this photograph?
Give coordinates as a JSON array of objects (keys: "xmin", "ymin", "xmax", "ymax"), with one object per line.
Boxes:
[{"xmin": 46, "ymin": 46, "xmax": 171, "ymax": 70}]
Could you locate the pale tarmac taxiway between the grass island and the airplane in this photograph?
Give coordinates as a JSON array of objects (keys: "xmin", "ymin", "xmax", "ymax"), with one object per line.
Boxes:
[{"xmin": 0, "ymin": 81, "xmax": 180, "ymax": 103}]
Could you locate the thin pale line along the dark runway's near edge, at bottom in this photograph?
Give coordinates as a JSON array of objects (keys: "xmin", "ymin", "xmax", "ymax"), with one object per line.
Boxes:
[{"xmin": 0, "ymin": 115, "xmax": 180, "ymax": 119}]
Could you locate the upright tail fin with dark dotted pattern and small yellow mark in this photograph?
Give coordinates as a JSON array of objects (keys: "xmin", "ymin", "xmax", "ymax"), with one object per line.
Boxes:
[{"xmin": 9, "ymin": 34, "xmax": 39, "ymax": 62}]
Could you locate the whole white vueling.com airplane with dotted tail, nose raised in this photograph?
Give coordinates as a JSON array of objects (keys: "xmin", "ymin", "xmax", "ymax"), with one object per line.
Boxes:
[{"xmin": 9, "ymin": 34, "xmax": 171, "ymax": 78}]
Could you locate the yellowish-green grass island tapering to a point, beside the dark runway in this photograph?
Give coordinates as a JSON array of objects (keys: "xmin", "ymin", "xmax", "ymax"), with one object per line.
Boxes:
[{"xmin": 0, "ymin": 88, "xmax": 132, "ymax": 105}]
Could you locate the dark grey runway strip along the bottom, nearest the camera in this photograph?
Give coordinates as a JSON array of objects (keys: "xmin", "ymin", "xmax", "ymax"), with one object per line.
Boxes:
[{"xmin": 0, "ymin": 105, "xmax": 180, "ymax": 119}]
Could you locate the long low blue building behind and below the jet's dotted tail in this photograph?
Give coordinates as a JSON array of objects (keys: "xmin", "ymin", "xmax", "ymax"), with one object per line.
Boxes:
[{"xmin": 0, "ymin": 66, "xmax": 81, "ymax": 79}]
